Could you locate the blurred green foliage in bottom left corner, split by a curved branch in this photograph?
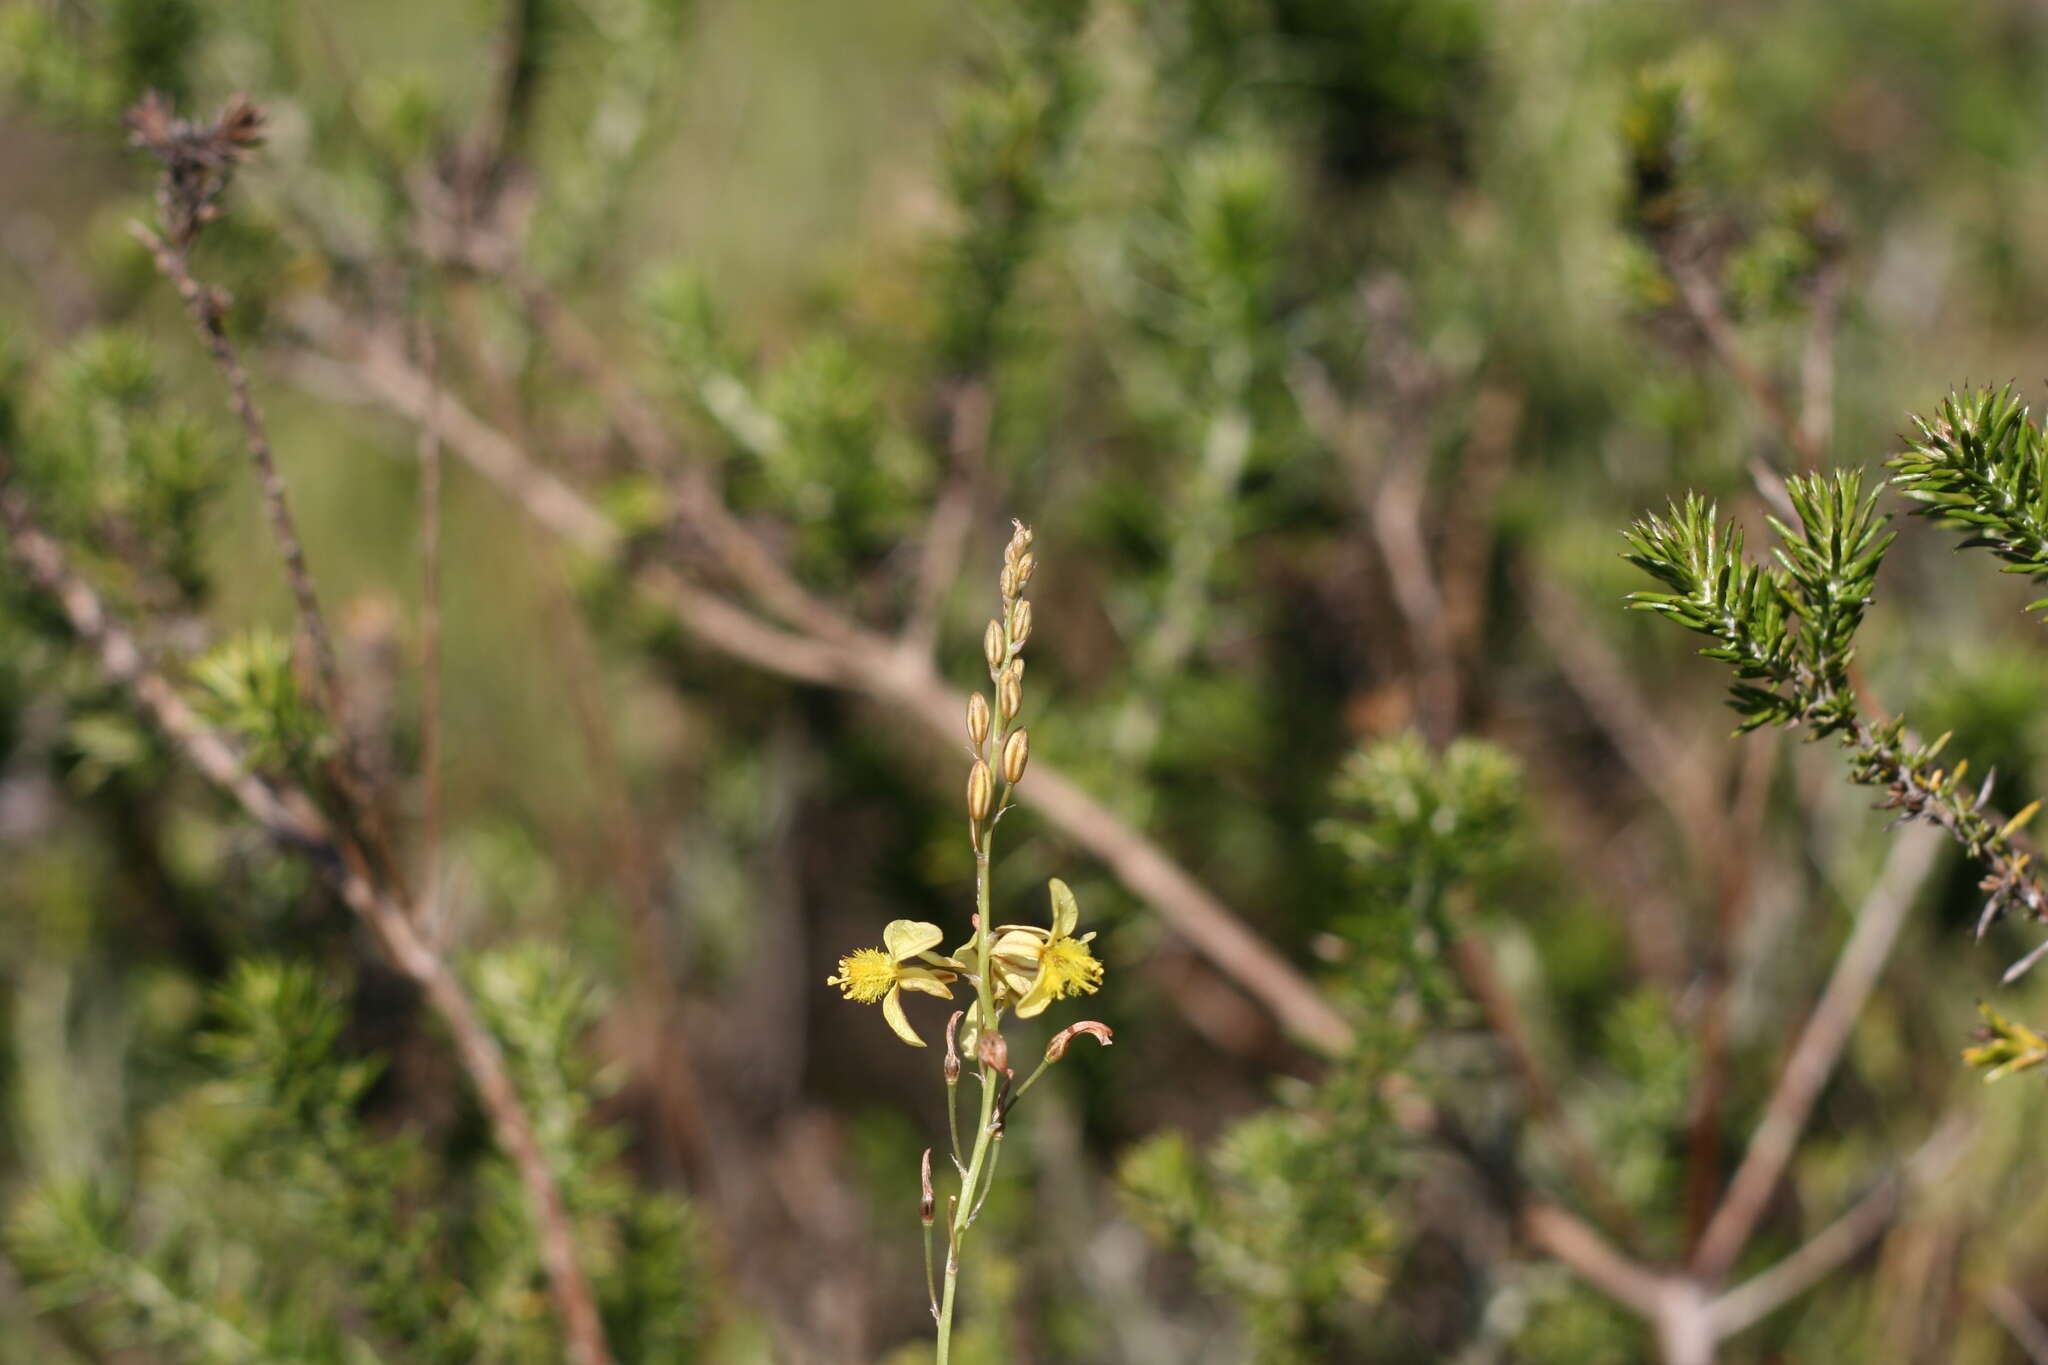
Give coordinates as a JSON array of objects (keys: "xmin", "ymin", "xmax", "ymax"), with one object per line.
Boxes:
[{"xmin": 4, "ymin": 954, "xmax": 705, "ymax": 1365}]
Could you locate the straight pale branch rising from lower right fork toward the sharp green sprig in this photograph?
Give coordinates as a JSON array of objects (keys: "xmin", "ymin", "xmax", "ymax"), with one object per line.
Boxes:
[{"xmin": 1692, "ymin": 829, "xmax": 1944, "ymax": 1281}]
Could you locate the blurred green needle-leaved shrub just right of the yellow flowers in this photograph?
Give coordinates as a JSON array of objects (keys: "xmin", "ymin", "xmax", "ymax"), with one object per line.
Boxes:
[{"xmin": 1120, "ymin": 735, "xmax": 1563, "ymax": 1365}]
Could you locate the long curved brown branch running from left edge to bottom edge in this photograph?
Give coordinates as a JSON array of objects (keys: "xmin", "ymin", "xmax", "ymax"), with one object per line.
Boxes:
[{"xmin": 0, "ymin": 466, "xmax": 610, "ymax": 1365}]
